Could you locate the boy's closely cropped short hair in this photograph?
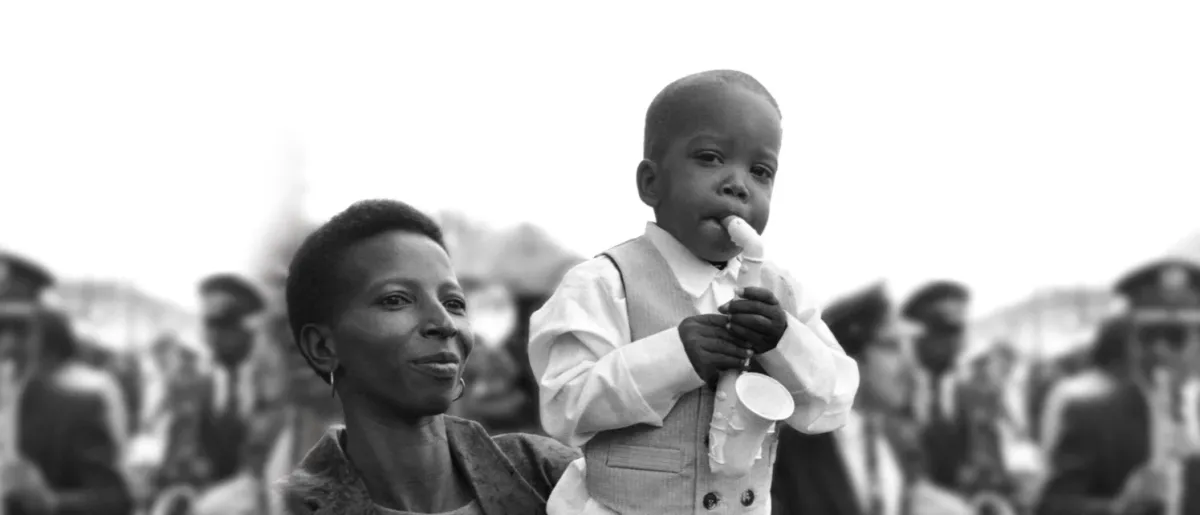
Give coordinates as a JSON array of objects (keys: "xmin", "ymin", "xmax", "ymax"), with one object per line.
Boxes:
[{"xmin": 642, "ymin": 70, "xmax": 784, "ymax": 161}]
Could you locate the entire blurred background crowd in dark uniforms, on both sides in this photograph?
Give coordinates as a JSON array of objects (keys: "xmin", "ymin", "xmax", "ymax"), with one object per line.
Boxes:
[{"xmin": 0, "ymin": 241, "xmax": 1200, "ymax": 515}]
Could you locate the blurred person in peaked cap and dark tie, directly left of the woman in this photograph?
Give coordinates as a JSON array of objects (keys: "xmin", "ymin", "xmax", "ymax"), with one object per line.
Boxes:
[{"xmin": 145, "ymin": 274, "xmax": 283, "ymax": 514}]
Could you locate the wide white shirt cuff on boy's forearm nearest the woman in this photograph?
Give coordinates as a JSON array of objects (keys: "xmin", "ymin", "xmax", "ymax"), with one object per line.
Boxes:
[{"xmin": 617, "ymin": 327, "xmax": 704, "ymax": 417}]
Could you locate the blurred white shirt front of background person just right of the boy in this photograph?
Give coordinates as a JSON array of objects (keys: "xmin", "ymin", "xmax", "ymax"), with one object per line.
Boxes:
[{"xmin": 834, "ymin": 411, "xmax": 904, "ymax": 515}]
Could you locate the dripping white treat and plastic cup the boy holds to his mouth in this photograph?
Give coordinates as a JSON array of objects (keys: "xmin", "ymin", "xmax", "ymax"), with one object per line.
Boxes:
[{"xmin": 708, "ymin": 216, "xmax": 796, "ymax": 478}]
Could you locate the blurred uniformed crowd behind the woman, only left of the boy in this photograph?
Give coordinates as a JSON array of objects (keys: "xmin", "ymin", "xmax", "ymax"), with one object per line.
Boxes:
[{"xmin": 0, "ymin": 246, "xmax": 548, "ymax": 515}]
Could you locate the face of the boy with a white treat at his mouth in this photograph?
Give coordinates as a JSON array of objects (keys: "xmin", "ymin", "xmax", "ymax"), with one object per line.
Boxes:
[{"xmin": 638, "ymin": 85, "xmax": 782, "ymax": 262}]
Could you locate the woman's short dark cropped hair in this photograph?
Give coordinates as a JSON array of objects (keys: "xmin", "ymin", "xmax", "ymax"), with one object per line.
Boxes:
[{"xmin": 286, "ymin": 199, "xmax": 445, "ymax": 382}]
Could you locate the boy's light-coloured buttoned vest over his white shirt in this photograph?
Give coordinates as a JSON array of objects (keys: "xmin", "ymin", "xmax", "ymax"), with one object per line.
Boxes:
[{"xmin": 583, "ymin": 236, "xmax": 796, "ymax": 515}]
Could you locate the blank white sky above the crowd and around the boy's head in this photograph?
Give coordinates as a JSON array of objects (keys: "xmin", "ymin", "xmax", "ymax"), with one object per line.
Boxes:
[{"xmin": 0, "ymin": 0, "xmax": 1200, "ymax": 310}]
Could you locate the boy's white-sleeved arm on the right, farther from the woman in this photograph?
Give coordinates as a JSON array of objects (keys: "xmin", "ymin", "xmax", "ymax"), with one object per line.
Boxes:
[{"xmin": 758, "ymin": 268, "xmax": 858, "ymax": 435}]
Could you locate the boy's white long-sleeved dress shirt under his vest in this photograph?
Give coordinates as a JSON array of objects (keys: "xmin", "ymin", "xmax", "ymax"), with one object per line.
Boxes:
[{"xmin": 529, "ymin": 223, "xmax": 858, "ymax": 514}]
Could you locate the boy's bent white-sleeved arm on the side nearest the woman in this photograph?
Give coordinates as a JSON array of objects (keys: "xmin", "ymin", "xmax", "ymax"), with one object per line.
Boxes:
[{"xmin": 529, "ymin": 257, "xmax": 704, "ymax": 447}]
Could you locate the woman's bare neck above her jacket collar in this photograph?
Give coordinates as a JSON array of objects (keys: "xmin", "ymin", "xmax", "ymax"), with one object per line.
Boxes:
[{"xmin": 344, "ymin": 402, "xmax": 469, "ymax": 513}]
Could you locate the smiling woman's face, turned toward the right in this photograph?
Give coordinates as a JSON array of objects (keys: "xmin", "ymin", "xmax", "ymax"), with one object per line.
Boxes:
[{"xmin": 329, "ymin": 230, "xmax": 473, "ymax": 417}]
